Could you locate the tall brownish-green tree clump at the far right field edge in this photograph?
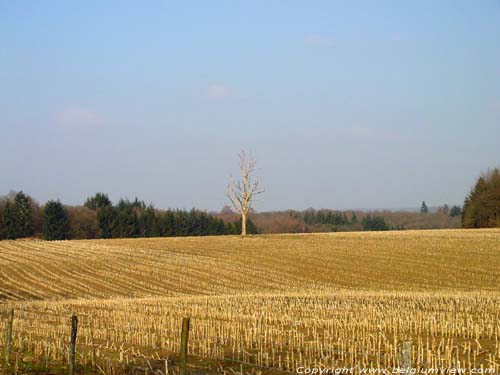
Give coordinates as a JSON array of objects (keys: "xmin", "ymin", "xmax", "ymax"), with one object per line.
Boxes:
[{"xmin": 462, "ymin": 168, "xmax": 500, "ymax": 228}]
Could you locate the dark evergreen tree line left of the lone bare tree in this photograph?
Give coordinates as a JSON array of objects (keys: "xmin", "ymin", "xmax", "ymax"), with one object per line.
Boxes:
[{"xmin": 0, "ymin": 191, "xmax": 258, "ymax": 240}]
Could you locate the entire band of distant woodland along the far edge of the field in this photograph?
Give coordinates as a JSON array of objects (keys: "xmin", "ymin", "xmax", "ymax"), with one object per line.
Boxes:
[{"xmin": 0, "ymin": 169, "xmax": 500, "ymax": 240}]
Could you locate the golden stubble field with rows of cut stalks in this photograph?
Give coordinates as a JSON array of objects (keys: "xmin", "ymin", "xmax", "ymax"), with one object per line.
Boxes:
[{"xmin": 0, "ymin": 230, "xmax": 500, "ymax": 374}]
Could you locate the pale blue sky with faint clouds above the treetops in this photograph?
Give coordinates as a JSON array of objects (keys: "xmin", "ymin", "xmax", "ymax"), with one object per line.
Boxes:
[{"xmin": 0, "ymin": 0, "xmax": 500, "ymax": 210}]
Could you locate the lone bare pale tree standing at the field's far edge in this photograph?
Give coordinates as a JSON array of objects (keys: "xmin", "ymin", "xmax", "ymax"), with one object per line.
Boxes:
[{"xmin": 227, "ymin": 151, "xmax": 264, "ymax": 237}]
